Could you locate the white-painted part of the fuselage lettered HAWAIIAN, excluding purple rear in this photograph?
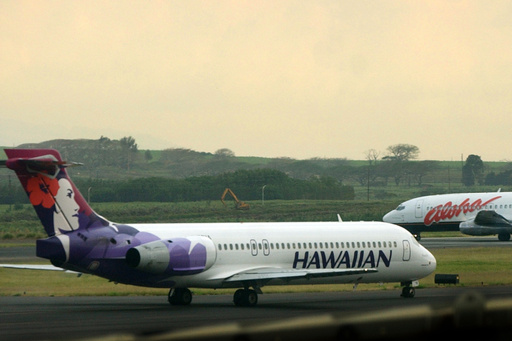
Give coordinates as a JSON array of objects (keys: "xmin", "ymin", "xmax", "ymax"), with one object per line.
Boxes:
[{"xmin": 131, "ymin": 222, "xmax": 436, "ymax": 288}]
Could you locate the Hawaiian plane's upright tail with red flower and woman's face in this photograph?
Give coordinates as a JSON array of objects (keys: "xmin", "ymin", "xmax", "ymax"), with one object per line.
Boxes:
[{"xmin": 4, "ymin": 149, "xmax": 109, "ymax": 237}]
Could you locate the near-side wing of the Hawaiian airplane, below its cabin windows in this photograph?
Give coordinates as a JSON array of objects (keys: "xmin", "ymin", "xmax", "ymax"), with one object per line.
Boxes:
[{"xmin": 224, "ymin": 268, "xmax": 377, "ymax": 282}]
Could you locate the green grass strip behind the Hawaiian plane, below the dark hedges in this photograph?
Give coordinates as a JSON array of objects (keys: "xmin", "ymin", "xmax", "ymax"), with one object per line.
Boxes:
[{"xmin": 0, "ymin": 200, "xmax": 397, "ymax": 241}]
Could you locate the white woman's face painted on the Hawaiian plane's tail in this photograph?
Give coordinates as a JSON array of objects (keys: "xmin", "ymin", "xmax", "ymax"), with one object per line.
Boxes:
[{"xmin": 53, "ymin": 178, "xmax": 80, "ymax": 234}]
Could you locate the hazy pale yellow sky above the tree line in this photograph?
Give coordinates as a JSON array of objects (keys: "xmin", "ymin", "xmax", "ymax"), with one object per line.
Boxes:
[{"xmin": 0, "ymin": 0, "xmax": 512, "ymax": 161}]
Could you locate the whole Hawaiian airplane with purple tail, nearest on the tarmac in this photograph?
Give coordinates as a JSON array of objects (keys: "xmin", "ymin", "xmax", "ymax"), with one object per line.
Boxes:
[{"xmin": 4, "ymin": 149, "xmax": 436, "ymax": 306}]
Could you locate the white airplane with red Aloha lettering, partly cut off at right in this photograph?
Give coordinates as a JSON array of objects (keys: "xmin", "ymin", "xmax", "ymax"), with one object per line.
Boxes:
[{"xmin": 382, "ymin": 191, "xmax": 512, "ymax": 241}]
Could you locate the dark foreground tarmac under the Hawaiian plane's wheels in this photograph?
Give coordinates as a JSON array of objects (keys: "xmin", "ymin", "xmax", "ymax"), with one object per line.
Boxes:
[{"xmin": 0, "ymin": 287, "xmax": 512, "ymax": 340}]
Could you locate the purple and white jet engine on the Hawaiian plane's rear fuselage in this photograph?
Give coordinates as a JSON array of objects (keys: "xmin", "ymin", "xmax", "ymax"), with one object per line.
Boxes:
[{"xmin": 126, "ymin": 236, "xmax": 217, "ymax": 275}]
